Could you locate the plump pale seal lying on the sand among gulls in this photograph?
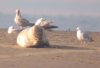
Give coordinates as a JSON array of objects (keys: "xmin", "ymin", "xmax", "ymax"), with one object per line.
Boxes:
[{"xmin": 17, "ymin": 25, "xmax": 49, "ymax": 48}]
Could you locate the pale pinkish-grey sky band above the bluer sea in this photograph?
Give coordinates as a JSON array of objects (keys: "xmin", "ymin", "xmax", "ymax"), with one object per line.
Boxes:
[{"xmin": 0, "ymin": 0, "xmax": 100, "ymax": 16}]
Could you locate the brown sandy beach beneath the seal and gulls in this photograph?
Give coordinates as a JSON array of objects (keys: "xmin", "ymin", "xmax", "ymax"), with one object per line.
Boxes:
[{"xmin": 0, "ymin": 29, "xmax": 100, "ymax": 68}]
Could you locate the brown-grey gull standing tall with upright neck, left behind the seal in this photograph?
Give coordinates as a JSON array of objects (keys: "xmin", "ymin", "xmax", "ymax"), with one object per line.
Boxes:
[{"xmin": 14, "ymin": 9, "xmax": 34, "ymax": 28}]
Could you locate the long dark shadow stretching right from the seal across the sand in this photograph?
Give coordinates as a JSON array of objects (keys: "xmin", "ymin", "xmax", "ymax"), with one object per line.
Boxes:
[{"xmin": 26, "ymin": 44, "xmax": 95, "ymax": 50}]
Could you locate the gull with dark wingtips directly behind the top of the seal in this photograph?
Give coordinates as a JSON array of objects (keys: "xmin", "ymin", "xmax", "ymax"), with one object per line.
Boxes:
[{"xmin": 35, "ymin": 18, "xmax": 58, "ymax": 29}]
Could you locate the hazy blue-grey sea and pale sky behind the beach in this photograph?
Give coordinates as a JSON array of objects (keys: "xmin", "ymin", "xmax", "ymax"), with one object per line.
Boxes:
[{"xmin": 0, "ymin": 0, "xmax": 100, "ymax": 32}]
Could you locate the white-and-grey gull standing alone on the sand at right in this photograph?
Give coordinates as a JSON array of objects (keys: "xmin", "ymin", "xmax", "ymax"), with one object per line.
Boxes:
[{"xmin": 76, "ymin": 27, "xmax": 93, "ymax": 43}]
